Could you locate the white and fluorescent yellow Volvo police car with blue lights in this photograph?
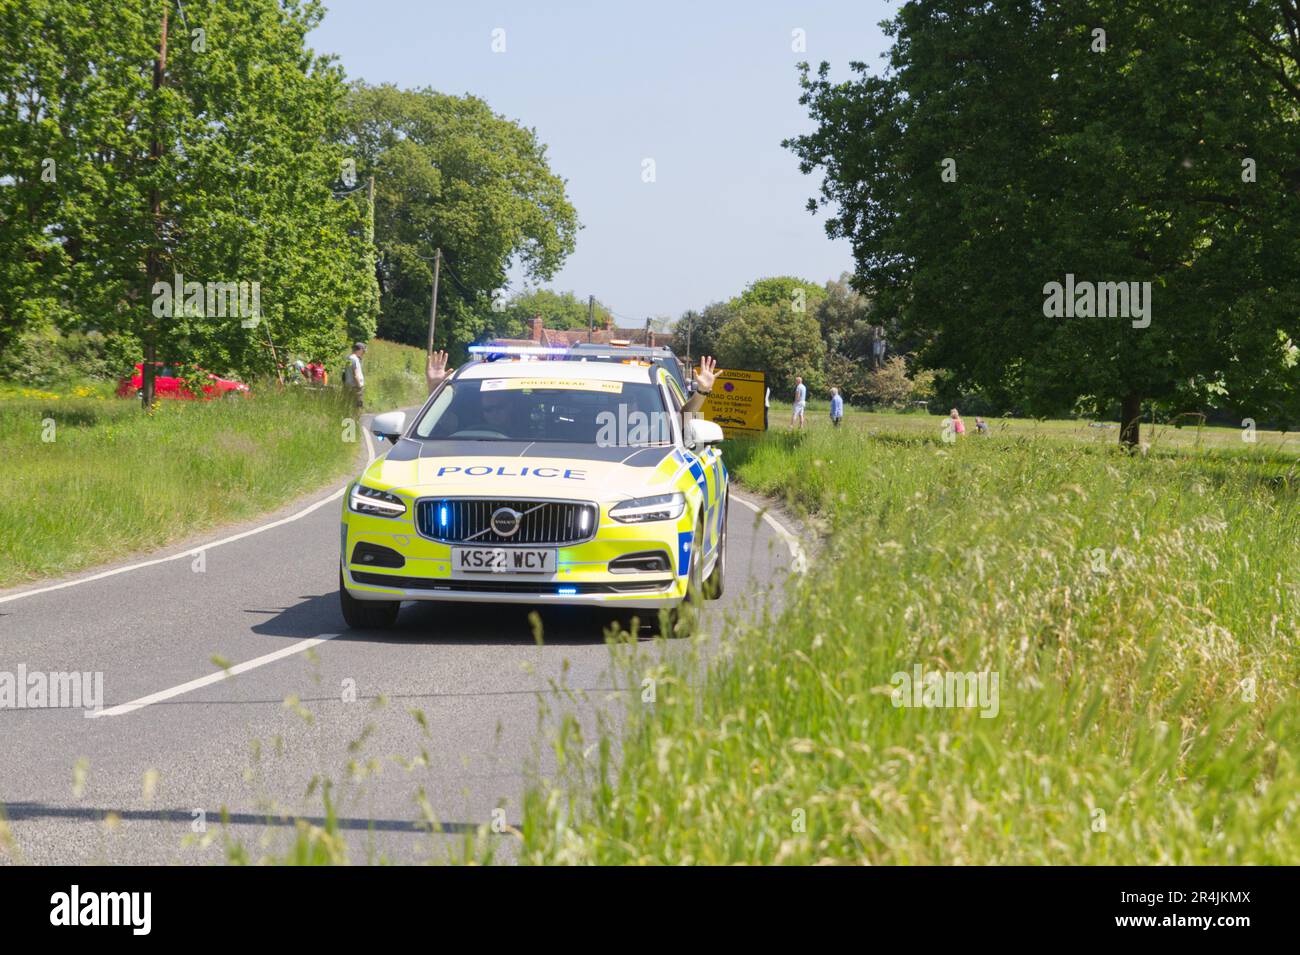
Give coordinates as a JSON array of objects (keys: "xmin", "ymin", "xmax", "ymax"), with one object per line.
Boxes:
[{"xmin": 339, "ymin": 356, "xmax": 728, "ymax": 629}]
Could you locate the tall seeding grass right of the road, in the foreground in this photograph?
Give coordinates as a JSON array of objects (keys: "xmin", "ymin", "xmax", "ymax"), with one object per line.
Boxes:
[{"xmin": 520, "ymin": 427, "xmax": 1300, "ymax": 864}]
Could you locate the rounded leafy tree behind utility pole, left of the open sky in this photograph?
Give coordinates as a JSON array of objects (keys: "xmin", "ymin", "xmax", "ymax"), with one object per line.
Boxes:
[{"xmin": 343, "ymin": 83, "xmax": 585, "ymax": 351}]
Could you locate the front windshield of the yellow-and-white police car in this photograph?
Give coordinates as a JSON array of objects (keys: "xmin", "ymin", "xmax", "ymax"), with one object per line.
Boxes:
[{"xmin": 415, "ymin": 376, "xmax": 672, "ymax": 447}]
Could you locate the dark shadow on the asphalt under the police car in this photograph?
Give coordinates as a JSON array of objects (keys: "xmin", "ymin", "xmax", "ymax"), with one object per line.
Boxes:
[{"xmin": 244, "ymin": 591, "xmax": 658, "ymax": 647}]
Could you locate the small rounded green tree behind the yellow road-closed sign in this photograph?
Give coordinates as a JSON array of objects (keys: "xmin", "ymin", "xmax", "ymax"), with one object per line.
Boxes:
[{"xmin": 698, "ymin": 304, "xmax": 826, "ymax": 394}]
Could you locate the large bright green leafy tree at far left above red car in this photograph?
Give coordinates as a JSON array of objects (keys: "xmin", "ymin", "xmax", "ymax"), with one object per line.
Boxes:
[{"xmin": 0, "ymin": 0, "xmax": 374, "ymax": 394}]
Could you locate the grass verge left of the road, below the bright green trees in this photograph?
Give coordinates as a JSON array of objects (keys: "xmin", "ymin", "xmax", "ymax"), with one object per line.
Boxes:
[{"xmin": 0, "ymin": 386, "xmax": 364, "ymax": 586}]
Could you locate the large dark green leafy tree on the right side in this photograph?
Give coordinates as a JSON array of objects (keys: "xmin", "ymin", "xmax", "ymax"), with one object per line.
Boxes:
[{"xmin": 789, "ymin": 0, "xmax": 1300, "ymax": 443}]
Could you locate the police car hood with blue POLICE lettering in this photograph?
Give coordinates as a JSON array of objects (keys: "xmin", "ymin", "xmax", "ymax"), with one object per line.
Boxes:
[{"xmin": 363, "ymin": 438, "xmax": 689, "ymax": 502}]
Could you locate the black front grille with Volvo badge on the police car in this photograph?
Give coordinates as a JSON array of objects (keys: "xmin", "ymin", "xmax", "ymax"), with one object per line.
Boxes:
[{"xmin": 416, "ymin": 498, "xmax": 599, "ymax": 544}]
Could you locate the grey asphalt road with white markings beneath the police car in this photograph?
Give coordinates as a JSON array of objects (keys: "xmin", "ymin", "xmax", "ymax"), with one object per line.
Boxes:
[{"xmin": 0, "ymin": 423, "xmax": 792, "ymax": 864}]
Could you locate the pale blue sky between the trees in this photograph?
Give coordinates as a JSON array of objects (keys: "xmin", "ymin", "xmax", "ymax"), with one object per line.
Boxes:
[{"xmin": 309, "ymin": 0, "xmax": 896, "ymax": 324}]
